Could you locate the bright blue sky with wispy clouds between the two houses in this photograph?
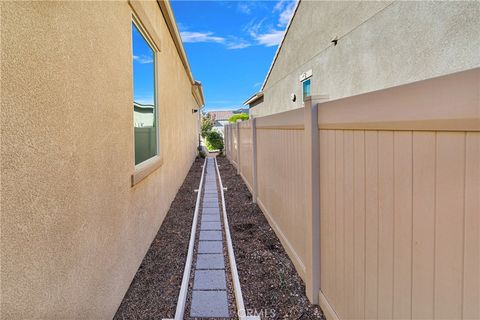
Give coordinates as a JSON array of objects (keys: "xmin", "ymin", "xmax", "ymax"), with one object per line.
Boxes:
[{"xmin": 171, "ymin": 0, "xmax": 295, "ymax": 110}]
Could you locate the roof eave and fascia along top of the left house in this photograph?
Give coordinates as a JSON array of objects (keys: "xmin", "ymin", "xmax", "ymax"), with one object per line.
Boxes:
[{"xmin": 157, "ymin": 0, "xmax": 205, "ymax": 106}]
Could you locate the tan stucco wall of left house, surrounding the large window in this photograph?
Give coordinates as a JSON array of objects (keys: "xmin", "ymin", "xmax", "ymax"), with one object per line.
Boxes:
[{"xmin": 0, "ymin": 1, "xmax": 197, "ymax": 319}]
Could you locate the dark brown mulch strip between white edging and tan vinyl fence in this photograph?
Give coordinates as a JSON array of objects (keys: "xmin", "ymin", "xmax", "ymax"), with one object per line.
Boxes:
[{"xmin": 217, "ymin": 157, "xmax": 323, "ymax": 319}]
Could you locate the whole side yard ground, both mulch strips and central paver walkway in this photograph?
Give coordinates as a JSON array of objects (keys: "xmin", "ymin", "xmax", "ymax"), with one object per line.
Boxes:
[{"xmin": 114, "ymin": 157, "xmax": 323, "ymax": 319}]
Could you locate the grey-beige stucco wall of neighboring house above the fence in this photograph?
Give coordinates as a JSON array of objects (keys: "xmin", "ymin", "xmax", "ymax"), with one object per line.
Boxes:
[{"xmin": 251, "ymin": 0, "xmax": 480, "ymax": 116}]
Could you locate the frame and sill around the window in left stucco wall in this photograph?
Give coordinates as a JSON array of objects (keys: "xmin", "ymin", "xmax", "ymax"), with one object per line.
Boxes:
[{"xmin": 130, "ymin": 12, "xmax": 163, "ymax": 187}]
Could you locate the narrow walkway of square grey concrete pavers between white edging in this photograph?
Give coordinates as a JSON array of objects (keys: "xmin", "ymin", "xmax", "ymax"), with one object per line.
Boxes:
[{"xmin": 190, "ymin": 158, "xmax": 230, "ymax": 318}]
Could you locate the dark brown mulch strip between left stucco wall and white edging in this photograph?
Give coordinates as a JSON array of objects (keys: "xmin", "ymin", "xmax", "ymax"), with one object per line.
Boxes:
[{"xmin": 114, "ymin": 158, "xmax": 204, "ymax": 319}]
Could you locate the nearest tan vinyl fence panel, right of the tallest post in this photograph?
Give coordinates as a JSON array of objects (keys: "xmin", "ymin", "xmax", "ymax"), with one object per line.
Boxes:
[{"xmin": 318, "ymin": 69, "xmax": 480, "ymax": 319}]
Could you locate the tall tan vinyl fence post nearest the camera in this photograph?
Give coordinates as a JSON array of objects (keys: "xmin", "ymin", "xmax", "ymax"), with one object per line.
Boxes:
[{"xmin": 304, "ymin": 97, "xmax": 320, "ymax": 304}]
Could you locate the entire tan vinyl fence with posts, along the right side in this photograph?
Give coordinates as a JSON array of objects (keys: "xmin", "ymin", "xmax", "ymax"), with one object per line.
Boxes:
[{"xmin": 225, "ymin": 69, "xmax": 480, "ymax": 319}]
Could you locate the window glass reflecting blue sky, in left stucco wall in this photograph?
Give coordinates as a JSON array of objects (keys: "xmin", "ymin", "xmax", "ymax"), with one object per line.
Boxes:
[{"xmin": 132, "ymin": 22, "xmax": 158, "ymax": 164}]
